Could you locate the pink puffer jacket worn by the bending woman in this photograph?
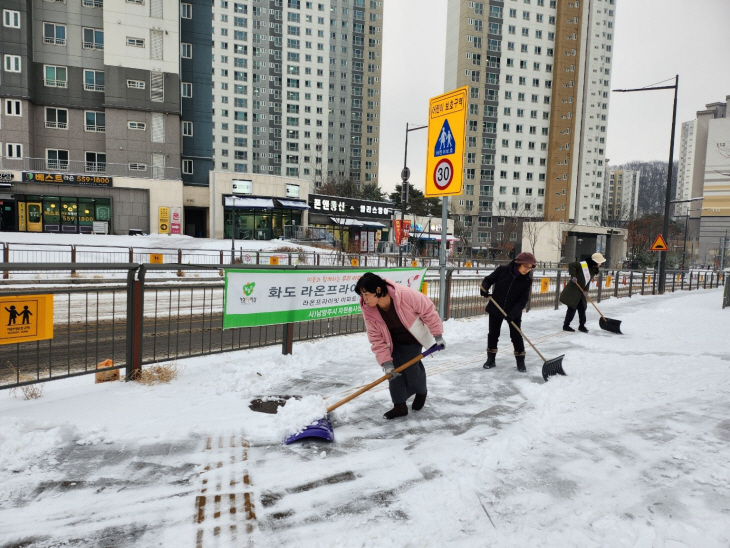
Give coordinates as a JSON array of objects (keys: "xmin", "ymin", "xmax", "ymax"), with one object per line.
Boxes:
[{"xmin": 360, "ymin": 280, "xmax": 444, "ymax": 365}]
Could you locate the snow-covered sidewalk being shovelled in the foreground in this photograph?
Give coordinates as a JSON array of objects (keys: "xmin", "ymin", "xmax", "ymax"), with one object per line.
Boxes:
[{"xmin": 0, "ymin": 282, "xmax": 730, "ymax": 548}]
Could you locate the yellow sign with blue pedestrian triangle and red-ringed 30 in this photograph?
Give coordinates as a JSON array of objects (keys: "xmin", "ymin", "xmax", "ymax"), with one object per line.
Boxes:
[{"xmin": 424, "ymin": 86, "xmax": 469, "ymax": 197}]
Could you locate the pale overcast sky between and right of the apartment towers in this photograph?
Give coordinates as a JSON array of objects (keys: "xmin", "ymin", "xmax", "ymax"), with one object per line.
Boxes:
[{"xmin": 379, "ymin": 0, "xmax": 730, "ymax": 197}]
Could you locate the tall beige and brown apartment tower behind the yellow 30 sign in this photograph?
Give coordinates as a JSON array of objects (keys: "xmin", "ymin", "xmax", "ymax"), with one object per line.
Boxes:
[{"xmin": 444, "ymin": 0, "xmax": 615, "ymax": 249}]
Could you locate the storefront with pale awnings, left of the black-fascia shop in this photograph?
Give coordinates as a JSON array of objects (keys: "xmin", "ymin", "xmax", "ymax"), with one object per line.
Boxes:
[{"xmin": 223, "ymin": 196, "xmax": 309, "ymax": 240}]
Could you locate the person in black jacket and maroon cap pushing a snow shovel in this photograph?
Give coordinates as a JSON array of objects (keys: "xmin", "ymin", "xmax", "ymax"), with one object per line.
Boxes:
[{"xmin": 479, "ymin": 253, "xmax": 537, "ymax": 372}]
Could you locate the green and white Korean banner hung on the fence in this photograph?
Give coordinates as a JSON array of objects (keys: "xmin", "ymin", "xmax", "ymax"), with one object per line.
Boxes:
[{"xmin": 223, "ymin": 268, "xmax": 426, "ymax": 329}]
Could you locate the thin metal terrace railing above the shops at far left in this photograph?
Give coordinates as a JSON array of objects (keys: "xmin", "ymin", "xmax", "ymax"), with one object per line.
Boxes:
[{"xmin": 0, "ymin": 156, "xmax": 180, "ymax": 182}]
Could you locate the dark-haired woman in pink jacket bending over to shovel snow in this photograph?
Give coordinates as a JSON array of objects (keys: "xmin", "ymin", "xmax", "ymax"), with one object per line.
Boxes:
[{"xmin": 355, "ymin": 272, "xmax": 445, "ymax": 419}]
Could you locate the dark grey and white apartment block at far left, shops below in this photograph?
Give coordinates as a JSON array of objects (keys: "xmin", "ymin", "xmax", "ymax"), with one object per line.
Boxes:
[{"xmin": 0, "ymin": 0, "xmax": 188, "ymax": 233}]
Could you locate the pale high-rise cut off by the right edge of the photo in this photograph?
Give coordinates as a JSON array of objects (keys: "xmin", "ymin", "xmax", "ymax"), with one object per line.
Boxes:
[{"xmin": 674, "ymin": 95, "xmax": 730, "ymax": 265}]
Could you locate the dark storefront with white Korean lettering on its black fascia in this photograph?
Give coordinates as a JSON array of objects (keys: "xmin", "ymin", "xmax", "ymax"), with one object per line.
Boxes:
[{"xmin": 309, "ymin": 194, "xmax": 393, "ymax": 253}]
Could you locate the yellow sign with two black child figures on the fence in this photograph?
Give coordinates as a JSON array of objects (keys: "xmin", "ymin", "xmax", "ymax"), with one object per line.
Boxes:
[{"xmin": 0, "ymin": 295, "xmax": 53, "ymax": 344}]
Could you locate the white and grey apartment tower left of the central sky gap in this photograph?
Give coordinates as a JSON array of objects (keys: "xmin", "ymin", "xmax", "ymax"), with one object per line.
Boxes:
[{"xmin": 212, "ymin": 0, "xmax": 383, "ymax": 189}]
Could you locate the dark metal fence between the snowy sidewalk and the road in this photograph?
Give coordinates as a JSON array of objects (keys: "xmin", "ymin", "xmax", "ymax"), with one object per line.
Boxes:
[{"xmin": 0, "ymin": 263, "xmax": 728, "ymax": 389}]
